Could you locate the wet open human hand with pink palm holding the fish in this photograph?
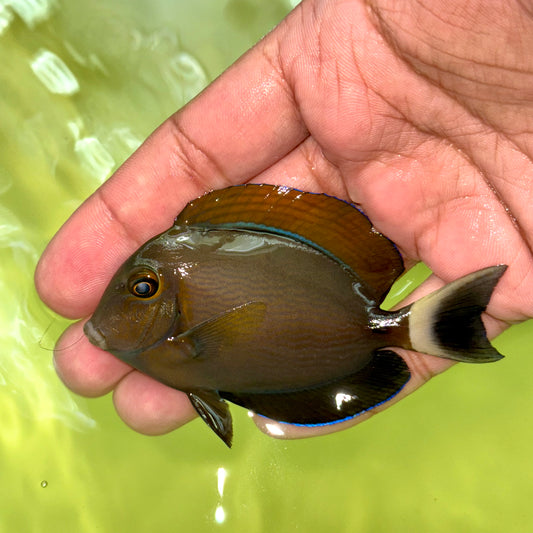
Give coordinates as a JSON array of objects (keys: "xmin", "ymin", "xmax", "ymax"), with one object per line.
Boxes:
[{"xmin": 36, "ymin": 0, "xmax": 533, "ymax": 434}]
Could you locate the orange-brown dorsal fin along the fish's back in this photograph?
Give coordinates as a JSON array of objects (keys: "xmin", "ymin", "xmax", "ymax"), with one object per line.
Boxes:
[{"xmin": 175, "ymin": 184, "xmax": 403, "ymax": 301}]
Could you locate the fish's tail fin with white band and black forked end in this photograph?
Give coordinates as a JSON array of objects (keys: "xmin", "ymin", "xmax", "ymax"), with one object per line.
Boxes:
[{"xmin": 409, "ymin": 265, "xmax": 507, "ymax": 363}]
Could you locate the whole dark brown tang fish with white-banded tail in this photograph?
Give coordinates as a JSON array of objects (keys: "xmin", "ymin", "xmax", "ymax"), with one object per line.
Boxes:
[{"xmin": 84, "ymin": 184, "xmax": 506, "ymax": 446}]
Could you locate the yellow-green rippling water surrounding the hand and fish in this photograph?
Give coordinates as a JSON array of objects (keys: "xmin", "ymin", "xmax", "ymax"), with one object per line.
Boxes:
[{"xmin": 0, "ymin": 0, "xmax": 533, "ymax": 533}]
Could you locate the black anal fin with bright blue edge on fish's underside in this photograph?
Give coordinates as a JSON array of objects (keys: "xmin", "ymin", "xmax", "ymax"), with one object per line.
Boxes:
[{"xmin": 220, "ymin": 350, "xmax": 410, "ymax": 426}]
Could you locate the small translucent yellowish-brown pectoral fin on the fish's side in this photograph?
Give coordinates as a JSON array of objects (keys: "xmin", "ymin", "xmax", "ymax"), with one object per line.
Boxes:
[{"xmin": 176, "ymin": 302, "xmax": 266, "ymax": 358}]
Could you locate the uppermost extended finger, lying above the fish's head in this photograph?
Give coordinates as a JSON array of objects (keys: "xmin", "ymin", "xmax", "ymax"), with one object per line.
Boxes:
[{"xmin": 35, "ymin": 28, "xmax": 307, "ymax": 318}]
